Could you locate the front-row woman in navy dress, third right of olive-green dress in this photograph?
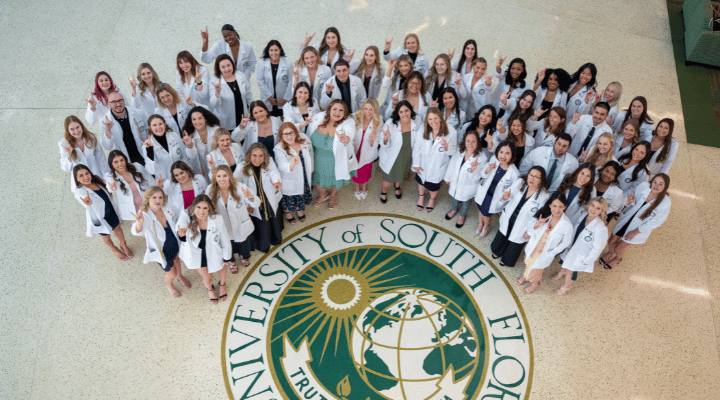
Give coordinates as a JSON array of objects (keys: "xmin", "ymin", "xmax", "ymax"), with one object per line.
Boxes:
[{"xmin": 475, "ymin": 142, "xmax": 520, "ymax": 238}]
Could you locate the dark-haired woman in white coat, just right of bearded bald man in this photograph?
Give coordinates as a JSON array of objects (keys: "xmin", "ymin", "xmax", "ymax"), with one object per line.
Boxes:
[{"xmin": 143, "ymin": 114, "xmax": 189, "ymax": 177}]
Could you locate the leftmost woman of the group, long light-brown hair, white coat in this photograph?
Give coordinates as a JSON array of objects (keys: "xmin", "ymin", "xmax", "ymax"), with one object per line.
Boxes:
[{"xmin": 58, "ymin": 115, "xmax": 110, "ymax": 191}]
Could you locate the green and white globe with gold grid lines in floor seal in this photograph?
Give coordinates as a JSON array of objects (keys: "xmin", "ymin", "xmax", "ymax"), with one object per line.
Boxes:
[{"xmin": 351, "ymin": 288, "xmax": 484, "ymax": 400}]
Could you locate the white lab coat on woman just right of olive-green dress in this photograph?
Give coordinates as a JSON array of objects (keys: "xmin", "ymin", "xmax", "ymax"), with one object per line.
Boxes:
[{"xmin": 412, "ymin": 126, "xmax": 457, "ymax": 183}]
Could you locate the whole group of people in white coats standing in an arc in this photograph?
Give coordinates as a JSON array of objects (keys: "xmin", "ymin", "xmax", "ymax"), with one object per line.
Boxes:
[{"xmin": 59, "ymin": 25, "xmax": 678, "ymax": 304}]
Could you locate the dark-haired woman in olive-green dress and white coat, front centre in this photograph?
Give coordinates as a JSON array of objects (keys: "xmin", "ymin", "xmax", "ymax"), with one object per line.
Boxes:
[{"xmin": 378, "ymin": 100, "xmax": 423, "ymax": 203}]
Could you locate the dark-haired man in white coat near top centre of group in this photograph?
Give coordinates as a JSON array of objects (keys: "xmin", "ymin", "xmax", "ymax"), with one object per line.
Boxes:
[{"xmin": 320, "ymin": 60, "xmax": 367, "ymax": 114}]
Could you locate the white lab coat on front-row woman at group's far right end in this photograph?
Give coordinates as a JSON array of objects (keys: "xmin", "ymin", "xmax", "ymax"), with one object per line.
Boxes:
[{"xmin": 613, "ymin": 182, "xmax": 671, "ymax": 244}]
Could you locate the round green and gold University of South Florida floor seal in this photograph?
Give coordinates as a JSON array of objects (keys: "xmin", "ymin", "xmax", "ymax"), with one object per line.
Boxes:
[{"xmin": 222, "ymin": 214, "xmax": 533, "ymax": 400}]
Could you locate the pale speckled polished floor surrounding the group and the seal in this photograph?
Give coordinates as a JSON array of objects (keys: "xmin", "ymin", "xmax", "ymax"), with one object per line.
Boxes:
[{"xmin": 0, "ymin": 0, "xmax": 720, "ymax": 400}]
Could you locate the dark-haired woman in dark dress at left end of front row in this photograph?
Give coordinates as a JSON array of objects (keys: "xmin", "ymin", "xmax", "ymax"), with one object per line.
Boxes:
[{"xmin": 72, "ymin": 164, "xmax": 133, "ymax": 261}]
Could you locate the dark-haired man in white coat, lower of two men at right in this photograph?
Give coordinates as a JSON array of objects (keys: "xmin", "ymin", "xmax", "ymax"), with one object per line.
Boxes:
[{"xmin": 520, "ymin": 133, "xmax": 578, "ymax": 193}]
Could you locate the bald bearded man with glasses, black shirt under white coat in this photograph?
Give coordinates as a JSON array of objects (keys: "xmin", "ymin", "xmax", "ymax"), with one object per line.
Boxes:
[{"xmin": 100, "ymin": 92, "xmax": 148, "ymax": 170}]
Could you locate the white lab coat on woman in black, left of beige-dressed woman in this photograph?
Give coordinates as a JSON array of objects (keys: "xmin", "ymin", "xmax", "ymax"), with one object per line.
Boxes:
[{"xmin": 498, "ymin": 178, "xmax": 550, "ymax": 244}]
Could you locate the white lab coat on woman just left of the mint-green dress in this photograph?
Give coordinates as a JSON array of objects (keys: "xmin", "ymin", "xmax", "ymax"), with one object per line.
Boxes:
[{"xmin": 275, "ymin": 133, "xmax": 315, "ymax": 196}]
